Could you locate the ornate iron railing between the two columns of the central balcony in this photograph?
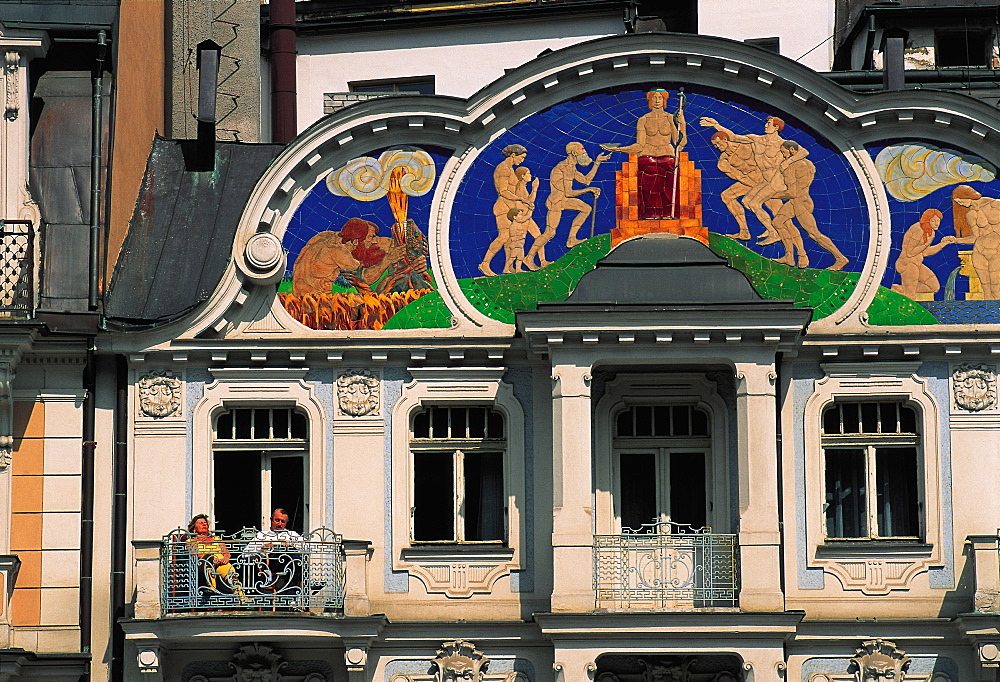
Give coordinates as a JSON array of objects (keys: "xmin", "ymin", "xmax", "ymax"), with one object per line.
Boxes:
[{"xmin": 594, "ymin": 522, "xmax": 738, "ymax": 610}]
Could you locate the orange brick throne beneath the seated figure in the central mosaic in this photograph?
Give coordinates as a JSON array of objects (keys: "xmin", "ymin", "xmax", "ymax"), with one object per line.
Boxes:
[{"xmin": 611, "ymin": 152, "xmax": 708, "ymax": 248}]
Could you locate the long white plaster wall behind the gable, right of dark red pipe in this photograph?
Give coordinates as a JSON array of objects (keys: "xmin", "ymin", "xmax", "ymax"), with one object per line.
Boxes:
[{"xmin": 296, "ymin": 14, "xmax": 625, "ymax": 131}]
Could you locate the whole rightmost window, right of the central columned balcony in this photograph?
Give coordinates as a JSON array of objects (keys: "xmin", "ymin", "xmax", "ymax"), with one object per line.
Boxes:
[{"xmin": 823, "ymin": 402, "xmax": 921, "ymax": 540}]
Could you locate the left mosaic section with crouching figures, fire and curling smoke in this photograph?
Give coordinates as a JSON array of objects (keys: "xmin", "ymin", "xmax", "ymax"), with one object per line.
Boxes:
[{"xmin": 278, "ymin": 148, "xmax": 450, "ymax": 330}]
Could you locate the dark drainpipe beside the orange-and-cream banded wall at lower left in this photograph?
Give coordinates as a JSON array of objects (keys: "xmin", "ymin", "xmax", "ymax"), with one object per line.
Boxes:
[{"xmin": 80, "ymin": 339, "xmax": 97, "ymax": 668}]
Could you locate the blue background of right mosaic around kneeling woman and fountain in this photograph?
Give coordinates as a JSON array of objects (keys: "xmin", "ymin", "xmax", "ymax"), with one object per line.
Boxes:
[{"xmin": 868, "ymin": 140, "xmax": 1000, "ymax": 324}]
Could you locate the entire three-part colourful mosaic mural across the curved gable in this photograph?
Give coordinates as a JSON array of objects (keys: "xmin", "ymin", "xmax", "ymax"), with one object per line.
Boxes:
[{"xmin": 279, "ymin": 84, "xmax": 1000, "ymax": 329}]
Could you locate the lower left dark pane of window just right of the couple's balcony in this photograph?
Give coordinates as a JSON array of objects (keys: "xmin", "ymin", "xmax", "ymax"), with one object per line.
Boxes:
[{"xmin": 413, "ymin": 452, "xmax": 457, "ymax": 541}]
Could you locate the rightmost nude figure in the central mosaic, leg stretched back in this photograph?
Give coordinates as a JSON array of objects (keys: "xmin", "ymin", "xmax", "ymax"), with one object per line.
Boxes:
[{"xmin": 773, "ymin": 140, "xmax": 848, "ymax": 270}]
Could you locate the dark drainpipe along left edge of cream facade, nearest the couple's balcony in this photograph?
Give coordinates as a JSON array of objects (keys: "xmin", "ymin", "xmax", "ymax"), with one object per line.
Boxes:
[{"xmin": 111, "ymin": 355, "xmax": 128, "ymax": 680}]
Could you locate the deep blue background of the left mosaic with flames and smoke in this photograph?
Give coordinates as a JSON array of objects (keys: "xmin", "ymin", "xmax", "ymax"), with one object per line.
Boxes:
[{"xmin": 282, "ymin": 146, "xmax": 451, "ymax": 279}]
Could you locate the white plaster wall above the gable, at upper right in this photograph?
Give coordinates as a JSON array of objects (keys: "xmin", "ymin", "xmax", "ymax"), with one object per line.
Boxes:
[{"xmin": 698, "ymin": 0, "xmax": 834, "ymax": 71}]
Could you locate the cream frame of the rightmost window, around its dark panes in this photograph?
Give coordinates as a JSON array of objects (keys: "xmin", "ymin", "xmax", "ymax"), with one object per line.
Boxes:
[{"xmin": 821, "ymin": 396, "xmax": 925, "ymax": 543}]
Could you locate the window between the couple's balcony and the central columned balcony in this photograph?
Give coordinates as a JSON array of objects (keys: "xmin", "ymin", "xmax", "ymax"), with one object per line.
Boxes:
[{"xmin": 411, "ymin": 407, "xmax": 507, "ymax": 543}]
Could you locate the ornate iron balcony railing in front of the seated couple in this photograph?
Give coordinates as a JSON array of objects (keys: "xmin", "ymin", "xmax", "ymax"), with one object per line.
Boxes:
[{"xmin": 160, "ymin": 528, "xmax": 344, "ymax": 614}]
